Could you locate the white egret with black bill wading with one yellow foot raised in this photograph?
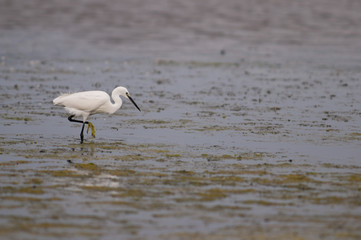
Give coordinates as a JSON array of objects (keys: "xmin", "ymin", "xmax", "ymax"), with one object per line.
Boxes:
[{"xmin": 53, "ymin": 87, "xmax": 140, "ymax": 143}]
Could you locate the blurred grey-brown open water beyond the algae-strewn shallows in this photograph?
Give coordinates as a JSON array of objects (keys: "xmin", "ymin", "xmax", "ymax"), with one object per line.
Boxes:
[{"xmin": 0, "ymin": 0, "xmax": 361, "ymax": 59}]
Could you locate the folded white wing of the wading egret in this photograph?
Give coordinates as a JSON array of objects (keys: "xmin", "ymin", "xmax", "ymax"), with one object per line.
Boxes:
[{"xmin": 53, "ymin": 91, "xmax": 110, "ymax": 113}]
